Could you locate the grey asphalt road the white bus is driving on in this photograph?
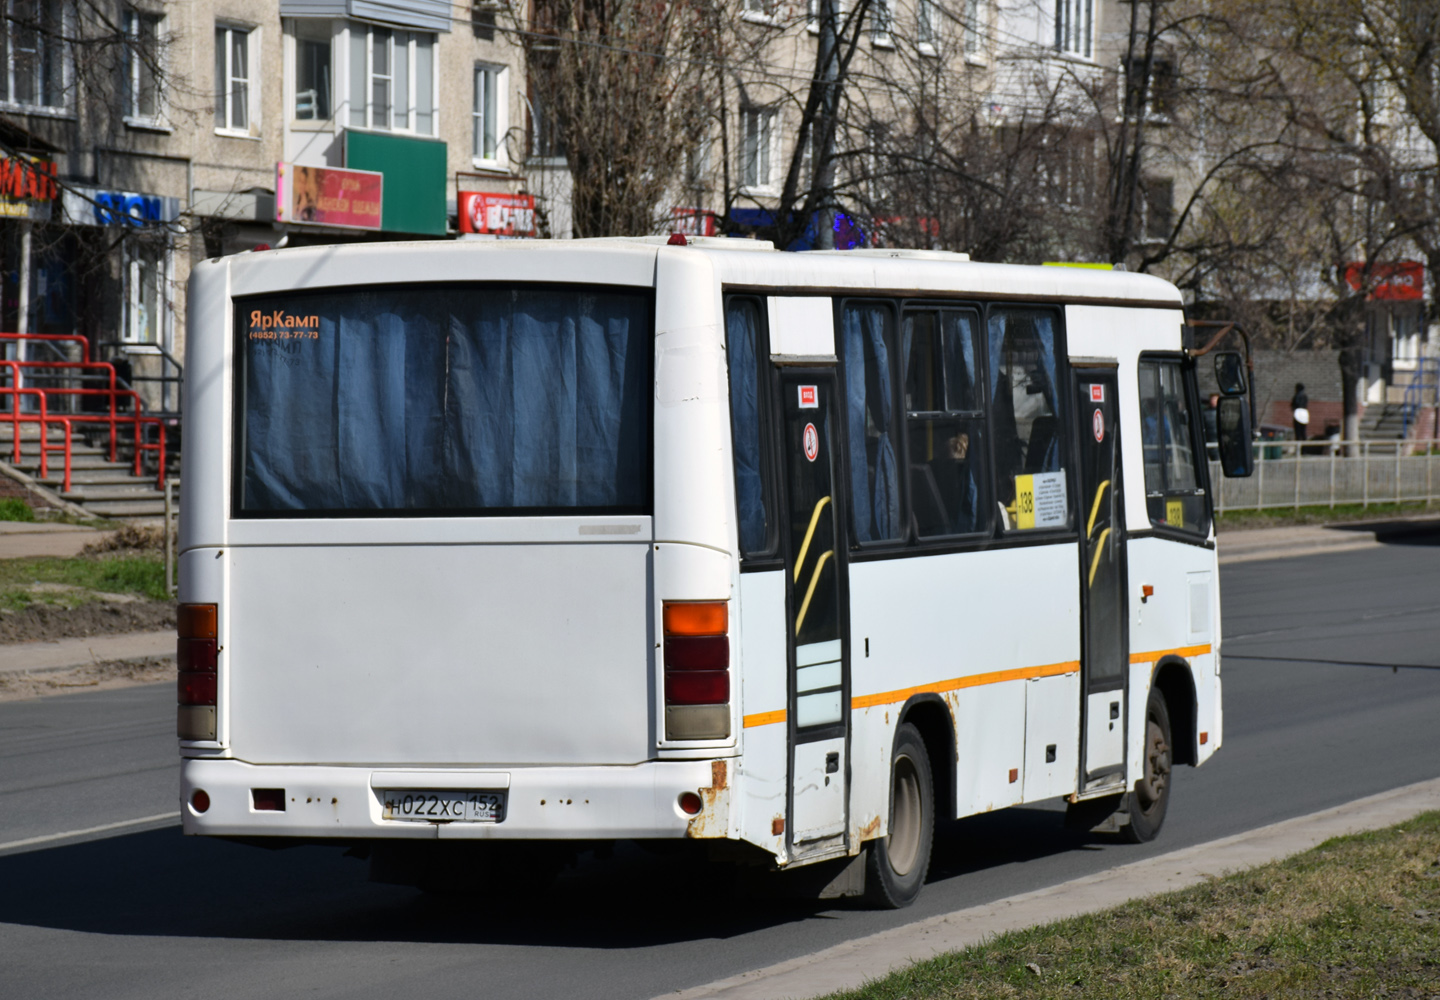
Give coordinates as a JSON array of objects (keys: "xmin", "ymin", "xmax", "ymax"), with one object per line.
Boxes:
[{"xmin": 0, "ymin": 535, "xmax": 1440, "ymax": 1000}]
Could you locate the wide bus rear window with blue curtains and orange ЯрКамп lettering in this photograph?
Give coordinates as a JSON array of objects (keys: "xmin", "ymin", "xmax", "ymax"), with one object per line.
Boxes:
[{"xmin": 236, "ymin": 285, "xmax": 652, "ymax": 516}]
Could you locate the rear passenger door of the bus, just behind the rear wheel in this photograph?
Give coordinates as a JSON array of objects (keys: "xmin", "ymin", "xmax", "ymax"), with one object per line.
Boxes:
[{"xmin": 778, "ymin": 369, "xmax": 850, "ymax": 857}]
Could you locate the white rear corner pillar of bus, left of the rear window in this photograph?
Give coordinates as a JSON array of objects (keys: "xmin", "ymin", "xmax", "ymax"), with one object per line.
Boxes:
[{"xmin": 180, "ymin": 261, "xmax": 232, "ymax": 556}]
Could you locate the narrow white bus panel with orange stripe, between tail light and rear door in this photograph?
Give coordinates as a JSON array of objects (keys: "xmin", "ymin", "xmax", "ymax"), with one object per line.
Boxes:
[{"xmin": 737, "ymin": 571, "xmax": 788, "ymax": 857}]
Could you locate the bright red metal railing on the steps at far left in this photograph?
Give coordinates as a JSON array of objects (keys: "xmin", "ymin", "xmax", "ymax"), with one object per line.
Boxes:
[{"xmin": 0, "ymin": 333, "xmax": 167, "ymax": 491}]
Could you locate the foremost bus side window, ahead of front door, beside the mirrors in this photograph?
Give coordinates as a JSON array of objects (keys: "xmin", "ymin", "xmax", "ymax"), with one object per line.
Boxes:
[{"xmin": 1138, "ymin": 360, "xmax": 1210, "ymax": 535}]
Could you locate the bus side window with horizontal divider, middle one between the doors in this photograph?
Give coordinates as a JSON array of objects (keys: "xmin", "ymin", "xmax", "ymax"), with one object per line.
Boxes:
[{"xmin": 901, "ymin": 308, "xmax": 991, "ymax": 537}]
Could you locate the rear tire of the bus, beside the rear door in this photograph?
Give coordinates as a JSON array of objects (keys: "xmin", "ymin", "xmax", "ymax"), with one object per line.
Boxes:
[{"xmin": 865, "ymin": 722, "xmax": 935, "ymax": 909}]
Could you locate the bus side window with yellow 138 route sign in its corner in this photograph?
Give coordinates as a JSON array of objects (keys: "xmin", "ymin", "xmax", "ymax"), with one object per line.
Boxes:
[{"xmin": 988, "ymin": 308, "xmax": 1070, "ymax": 530}]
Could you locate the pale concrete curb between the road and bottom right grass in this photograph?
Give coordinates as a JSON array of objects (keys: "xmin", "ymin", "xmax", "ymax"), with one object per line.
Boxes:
[{"xmin": 655, "ymin": 778, "xmax": 1440, "ymax": 1000}]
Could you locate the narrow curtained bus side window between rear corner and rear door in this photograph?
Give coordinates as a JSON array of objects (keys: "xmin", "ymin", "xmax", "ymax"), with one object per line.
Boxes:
[{"xmin": 724, "ymin": 297, "xmax": 776, "ymax": 558}]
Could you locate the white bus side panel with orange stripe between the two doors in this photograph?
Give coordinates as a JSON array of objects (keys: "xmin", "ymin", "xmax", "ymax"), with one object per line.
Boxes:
[{"xmin": 850, "ymin": 542, "xmax": 1080, "ymax": 833}]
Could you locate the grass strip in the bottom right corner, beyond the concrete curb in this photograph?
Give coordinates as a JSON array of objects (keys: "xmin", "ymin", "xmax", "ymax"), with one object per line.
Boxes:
[{"xmin": 831, "ymin": 813, "xmax": 1440, "ymax": 1000}]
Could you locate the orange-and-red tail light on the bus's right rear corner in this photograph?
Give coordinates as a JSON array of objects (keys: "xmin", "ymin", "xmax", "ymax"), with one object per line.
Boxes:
[{"xmin": 664, "ymin": 601, "xmax": 730, "ymax": 739}]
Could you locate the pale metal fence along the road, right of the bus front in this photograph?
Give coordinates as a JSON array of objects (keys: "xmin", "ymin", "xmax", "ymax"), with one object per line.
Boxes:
[{"xmin": 1210, "ymin": 441, "xmax": 1440, "ymax": 512}]
